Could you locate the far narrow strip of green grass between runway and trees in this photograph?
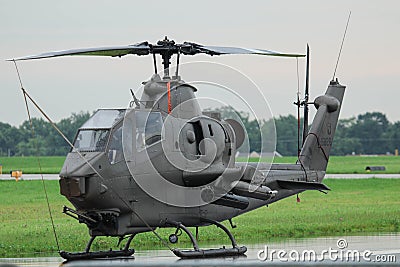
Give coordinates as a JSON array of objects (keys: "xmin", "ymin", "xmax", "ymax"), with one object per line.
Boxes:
[{"xmin": 0, "ymin": 156, "xmax": 400, "ymax": 175}]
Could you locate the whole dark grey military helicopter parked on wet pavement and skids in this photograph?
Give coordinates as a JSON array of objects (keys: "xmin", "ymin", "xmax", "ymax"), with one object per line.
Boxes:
[{"xmin": 11, "ymin": 37, "xmax": 345, "ymax": 260}]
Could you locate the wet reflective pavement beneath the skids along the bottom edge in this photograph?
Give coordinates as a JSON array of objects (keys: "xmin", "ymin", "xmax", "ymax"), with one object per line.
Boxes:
[{"xmin": 0, "ymin": 233, "xmax": 400, "ymax": 267}]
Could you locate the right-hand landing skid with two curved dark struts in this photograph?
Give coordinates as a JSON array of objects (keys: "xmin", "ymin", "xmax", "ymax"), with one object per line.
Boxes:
[{"xmin": 167, "ymin": 219, "xmax": 247, "ymax": 259}]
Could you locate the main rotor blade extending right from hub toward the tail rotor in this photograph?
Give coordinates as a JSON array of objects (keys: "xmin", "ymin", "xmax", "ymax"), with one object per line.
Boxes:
[{"xmin": 199, "ymin": 45, "xmax": 305, "ymax": 57}]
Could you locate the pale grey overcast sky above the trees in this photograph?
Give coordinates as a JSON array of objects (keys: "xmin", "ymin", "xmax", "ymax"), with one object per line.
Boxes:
[{"xmin": 0, "ymin": 0, "xmax": 400, "ymax": 125}]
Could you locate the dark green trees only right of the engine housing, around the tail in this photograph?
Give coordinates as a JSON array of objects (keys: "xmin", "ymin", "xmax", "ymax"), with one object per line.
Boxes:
[{"xmin": 214, "ymin": 108, "xmax": 400, "ymax": 156}]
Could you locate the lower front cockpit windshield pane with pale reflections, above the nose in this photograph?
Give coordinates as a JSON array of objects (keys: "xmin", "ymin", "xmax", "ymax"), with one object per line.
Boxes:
[{"xmin": 72, "ymin": 129, "xmax": 109, "ymax": 152}]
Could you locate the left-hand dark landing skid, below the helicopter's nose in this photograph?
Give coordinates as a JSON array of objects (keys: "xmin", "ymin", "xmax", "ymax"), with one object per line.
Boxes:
[{"xmin": 60, "ymin": 235, "xmax": 135, "ymax": 261}]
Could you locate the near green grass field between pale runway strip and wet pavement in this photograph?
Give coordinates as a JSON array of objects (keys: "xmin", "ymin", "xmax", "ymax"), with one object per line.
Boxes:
[{"xmin": 0, "ymin": 179, "xmax": 400, "ymax": 257}]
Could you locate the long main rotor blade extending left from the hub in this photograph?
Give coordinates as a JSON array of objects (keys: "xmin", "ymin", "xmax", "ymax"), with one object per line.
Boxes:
[{"xmin": 7, "ymin": 42, "xmax": 150, "ymax": 61}]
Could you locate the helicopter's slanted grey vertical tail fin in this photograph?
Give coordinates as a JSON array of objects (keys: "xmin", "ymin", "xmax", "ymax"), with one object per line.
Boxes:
[{"xmin": 299, "ymin": 79, "xmax": 346, "ymax": 171}]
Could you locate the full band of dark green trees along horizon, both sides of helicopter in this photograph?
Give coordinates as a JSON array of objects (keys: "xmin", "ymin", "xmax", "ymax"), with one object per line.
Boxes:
[{"xmin": 0, "ymin": 109, "xmax": 400, "ymax": 156}]
